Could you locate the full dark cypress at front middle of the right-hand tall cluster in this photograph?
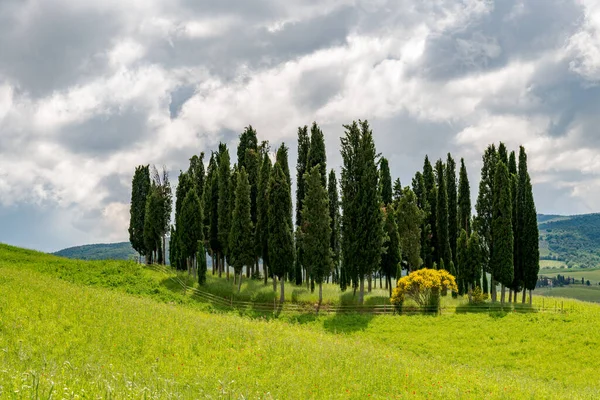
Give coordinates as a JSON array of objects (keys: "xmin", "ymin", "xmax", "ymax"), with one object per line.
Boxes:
[{"xmin": 490, "ymin": 161, "xmax": 514, "ymax": 304}]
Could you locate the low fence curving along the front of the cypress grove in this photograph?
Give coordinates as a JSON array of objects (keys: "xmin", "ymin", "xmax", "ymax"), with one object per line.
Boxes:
[{"xmin": 149, "ymin": 264, "xmax": 575, "ymax": 315}]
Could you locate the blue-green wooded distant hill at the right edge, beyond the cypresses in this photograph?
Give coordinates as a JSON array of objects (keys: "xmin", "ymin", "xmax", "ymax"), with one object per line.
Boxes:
[{"xmin": 538, "ymin": 214, "xmax": 600, "ymax": 268}]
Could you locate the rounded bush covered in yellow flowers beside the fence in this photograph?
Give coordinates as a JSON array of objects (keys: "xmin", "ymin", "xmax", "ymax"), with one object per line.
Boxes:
[{"xmin": 390, "ymin": 268, "xmax": 458, "ymax": 308}]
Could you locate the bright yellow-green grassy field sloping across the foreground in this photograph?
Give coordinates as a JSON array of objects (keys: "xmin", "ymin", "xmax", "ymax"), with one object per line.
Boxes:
[{"xmin": 0, "ymin": 245, "xmax": 600, "ymax": 399}]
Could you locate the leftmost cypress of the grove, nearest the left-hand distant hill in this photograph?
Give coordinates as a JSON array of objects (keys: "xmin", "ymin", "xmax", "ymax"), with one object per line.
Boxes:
[{"xmin": 129, "ymin": 165, "xmax": 150, "ymax": 257}]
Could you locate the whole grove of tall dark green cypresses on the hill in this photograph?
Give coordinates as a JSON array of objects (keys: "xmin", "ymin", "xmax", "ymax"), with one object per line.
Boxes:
[{"xmin": 129, "ymin": 120, "xmax": 539, "ymax": 304}]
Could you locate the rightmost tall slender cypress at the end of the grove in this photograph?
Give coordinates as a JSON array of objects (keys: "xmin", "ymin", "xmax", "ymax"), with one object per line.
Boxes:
[{"xmin": 517, "ymin": 147, "xmax": 540, "ymax": 304}]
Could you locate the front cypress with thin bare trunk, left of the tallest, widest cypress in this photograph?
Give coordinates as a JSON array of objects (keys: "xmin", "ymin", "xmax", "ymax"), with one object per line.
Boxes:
[{"xmin": 302, "ymin": 165, "xmax": 332, "ymax": 304}]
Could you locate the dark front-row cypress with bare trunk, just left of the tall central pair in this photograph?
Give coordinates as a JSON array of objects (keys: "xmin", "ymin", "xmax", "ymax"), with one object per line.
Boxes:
[{"xmin": 268, "ymin": 161, "xmax": 294, "ymax": 303}]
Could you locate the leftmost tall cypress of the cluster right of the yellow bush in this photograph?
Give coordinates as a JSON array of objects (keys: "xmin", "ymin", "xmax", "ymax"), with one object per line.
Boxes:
[{"xmin": 474, "ymin": 144, "xmax": 498, "ymax": 301}]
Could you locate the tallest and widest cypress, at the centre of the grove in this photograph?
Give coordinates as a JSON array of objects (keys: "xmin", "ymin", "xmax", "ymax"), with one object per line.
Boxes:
[{"xmin": 341, "ymin": 121, "xmax": 384, "ymax": 304}]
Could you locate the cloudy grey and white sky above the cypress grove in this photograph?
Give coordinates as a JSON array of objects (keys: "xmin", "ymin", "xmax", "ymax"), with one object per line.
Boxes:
[{"xmin": 0, "ymin": 0, "xmax": 600, "ymax": 251}]
